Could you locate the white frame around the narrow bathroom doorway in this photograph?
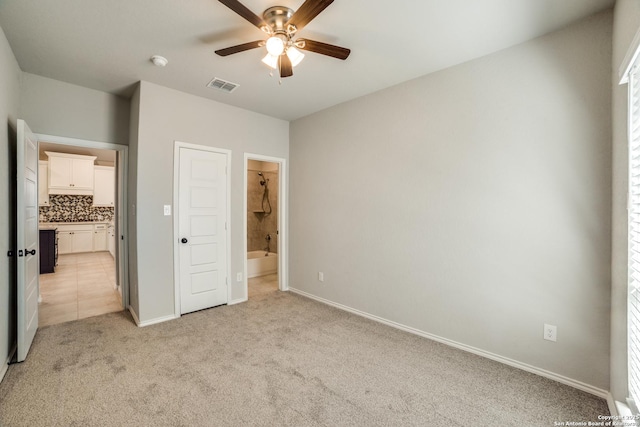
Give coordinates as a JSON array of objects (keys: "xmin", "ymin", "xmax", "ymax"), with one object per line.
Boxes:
[{"xmin": 242, "ymin": 153, "xmax": 289, "ymax": 301}]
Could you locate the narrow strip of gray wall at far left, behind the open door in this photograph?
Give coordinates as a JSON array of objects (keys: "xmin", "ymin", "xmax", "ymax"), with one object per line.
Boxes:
[{"xmin": 0, "ymin": 22, "xmax": 21, "ymax": 379}]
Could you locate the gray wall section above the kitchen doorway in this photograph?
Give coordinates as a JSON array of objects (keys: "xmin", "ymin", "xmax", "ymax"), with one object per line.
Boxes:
[{"xmin": 20, "ymin": 73, "xmax": 129, "ymax": 145}]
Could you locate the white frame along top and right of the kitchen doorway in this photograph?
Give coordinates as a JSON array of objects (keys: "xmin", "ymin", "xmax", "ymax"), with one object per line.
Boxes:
[{"xmin": 35, "ymin": 133, "xmax": 129, "ymax": 310}]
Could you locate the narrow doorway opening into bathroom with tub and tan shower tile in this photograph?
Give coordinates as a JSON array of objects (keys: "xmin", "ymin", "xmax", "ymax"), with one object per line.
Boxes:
[{"xmin": 244, "ymin": 154, "xmax": 286, "ymax": 298}]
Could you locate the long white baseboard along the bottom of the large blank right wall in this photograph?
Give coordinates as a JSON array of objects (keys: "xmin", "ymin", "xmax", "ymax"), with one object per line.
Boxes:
[{"xmin": 289, "ymin": 288, "xmax": 615, "ymax": 406}]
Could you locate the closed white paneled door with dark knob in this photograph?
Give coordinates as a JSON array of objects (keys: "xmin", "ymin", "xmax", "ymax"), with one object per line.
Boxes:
[{"xmin": 177, "ymin": 147, "xmax": 228, "ymax": 314}]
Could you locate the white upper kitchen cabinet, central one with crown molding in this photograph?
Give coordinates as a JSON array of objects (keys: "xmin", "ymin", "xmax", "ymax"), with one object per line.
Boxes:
[{"xmin": 45, "ymin": 151, "xmax": 96, "ymax": 196}]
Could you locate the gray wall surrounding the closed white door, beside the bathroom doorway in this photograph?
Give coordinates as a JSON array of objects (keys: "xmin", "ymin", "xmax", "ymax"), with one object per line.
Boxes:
[{"xmin": 136, "ymin": 82, "xmax": 289, "ymax": 322}]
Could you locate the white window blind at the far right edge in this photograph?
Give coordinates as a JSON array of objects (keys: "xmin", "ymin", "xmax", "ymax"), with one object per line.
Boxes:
[{"xmin": 627, "ymin": 66, "xmax": 640, "ymax": 411}]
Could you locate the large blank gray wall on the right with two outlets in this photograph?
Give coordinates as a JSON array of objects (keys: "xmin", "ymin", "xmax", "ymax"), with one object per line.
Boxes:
[{"xmin": 289, "ymin": 12, "xmax": 612, "ymax": 390}]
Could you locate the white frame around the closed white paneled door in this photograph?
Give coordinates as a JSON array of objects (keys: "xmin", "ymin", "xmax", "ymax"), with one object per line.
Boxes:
[{"xmin": 172, "ymin": 141, "xmax": 232, "ymax": 318}]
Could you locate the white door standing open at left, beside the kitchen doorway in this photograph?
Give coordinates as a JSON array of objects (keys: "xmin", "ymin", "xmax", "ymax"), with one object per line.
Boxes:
[{"xmin": 17, "ymin": 120, "xmax": 40, "ymax": 362}]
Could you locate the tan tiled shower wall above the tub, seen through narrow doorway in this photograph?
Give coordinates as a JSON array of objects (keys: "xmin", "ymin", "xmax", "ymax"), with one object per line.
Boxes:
[{"xmin": 247, "ymin": 170, "xmax": 279, "ymax": 253}]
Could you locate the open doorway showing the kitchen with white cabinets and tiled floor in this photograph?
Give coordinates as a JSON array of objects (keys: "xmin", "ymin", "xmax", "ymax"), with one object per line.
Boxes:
[{"xmin": 38, "ymin": 136, "xmax": 127, "ymax": 326}]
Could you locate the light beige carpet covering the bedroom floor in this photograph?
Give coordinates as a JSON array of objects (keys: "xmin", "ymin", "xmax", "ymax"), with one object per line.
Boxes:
[{"xmin": 0, "ymin": 291, "xmax": 608, "ymax": 427}]
